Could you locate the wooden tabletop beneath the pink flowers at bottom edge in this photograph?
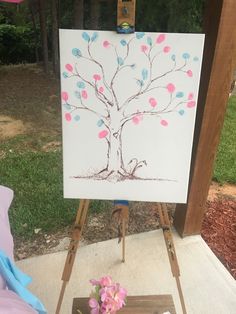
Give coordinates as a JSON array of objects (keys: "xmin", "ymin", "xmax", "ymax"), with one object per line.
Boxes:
[{"xmin": 72, "ymin": 294, "xmax": 176, "ymax": 314}]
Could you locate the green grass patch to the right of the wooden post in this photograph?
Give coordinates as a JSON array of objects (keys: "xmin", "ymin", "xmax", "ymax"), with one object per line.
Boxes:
[{"xmin": 213, "ymin": 96, "xmax": 236, "ymax": 184}]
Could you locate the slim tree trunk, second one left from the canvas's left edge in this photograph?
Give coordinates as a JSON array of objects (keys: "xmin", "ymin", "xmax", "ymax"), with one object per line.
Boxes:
[{"xmin": 39, "ymin": 0, "xmax": 49, "ymax": 73}]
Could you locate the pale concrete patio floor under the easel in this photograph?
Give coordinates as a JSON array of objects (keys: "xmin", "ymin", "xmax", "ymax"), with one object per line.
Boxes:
[{"xmin": 17, "ymin": 230, "xmax": 236, "ymax": 314}]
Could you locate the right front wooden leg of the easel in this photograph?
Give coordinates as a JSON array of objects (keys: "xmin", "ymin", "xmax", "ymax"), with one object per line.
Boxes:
[{"xmin": 157, "ymin": 204, "xmax": 187, "ymax": 314}]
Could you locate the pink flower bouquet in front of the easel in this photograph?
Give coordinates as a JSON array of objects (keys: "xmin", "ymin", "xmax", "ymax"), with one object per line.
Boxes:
[{"xmin": 89, "ymin": 276, "xmax": 127, "ymax": 314}]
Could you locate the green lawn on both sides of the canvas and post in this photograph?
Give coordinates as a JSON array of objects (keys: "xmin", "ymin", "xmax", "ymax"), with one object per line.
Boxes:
[{"xmin": 0, "ymin": 96, "xmax": 236, "ymax": 237}]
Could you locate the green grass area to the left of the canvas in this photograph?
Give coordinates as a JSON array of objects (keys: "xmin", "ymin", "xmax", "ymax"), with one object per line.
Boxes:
[{"xmin": 0, "ymin": 137, "xmax": 109, "ymax": 238}]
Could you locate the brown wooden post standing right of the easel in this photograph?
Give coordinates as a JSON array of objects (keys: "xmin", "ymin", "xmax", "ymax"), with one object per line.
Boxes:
[{"xmin": 174, "ymin": 0, "xmax": 236, "ymax": 236}]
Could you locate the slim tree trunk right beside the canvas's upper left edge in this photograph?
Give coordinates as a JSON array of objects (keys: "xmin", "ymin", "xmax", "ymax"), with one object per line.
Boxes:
[{"xmin": 51, "ymin": 0, "xmax": 59, "ymax": 75}]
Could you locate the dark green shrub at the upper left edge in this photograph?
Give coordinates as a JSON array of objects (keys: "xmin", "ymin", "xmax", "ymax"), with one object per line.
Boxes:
[{"xmin": 0, "ymin": 24, "xmax": 35, "ymax": 64}]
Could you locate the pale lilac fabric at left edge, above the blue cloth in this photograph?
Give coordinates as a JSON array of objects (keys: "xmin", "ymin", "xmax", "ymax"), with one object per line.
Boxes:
[{"xmin": 0, "ymin": 185, "xmax": 14, "ymax": 290}]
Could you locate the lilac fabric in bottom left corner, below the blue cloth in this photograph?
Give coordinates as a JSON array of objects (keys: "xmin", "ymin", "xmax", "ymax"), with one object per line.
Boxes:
[{"xmin": 0, "ymin": 290, "xmax": 37, "ymax": 314}]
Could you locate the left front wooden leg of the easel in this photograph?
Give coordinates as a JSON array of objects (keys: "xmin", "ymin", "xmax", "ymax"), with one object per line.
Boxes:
[{"xmin": 55, "ymin": 200, "xmax": 89, "ymax": 314}]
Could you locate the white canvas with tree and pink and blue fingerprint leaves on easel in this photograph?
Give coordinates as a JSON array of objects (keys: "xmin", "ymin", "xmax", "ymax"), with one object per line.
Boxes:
[{"xmin": 60, "ymin": 30, "xmax": 204, "ymax": 203}]
